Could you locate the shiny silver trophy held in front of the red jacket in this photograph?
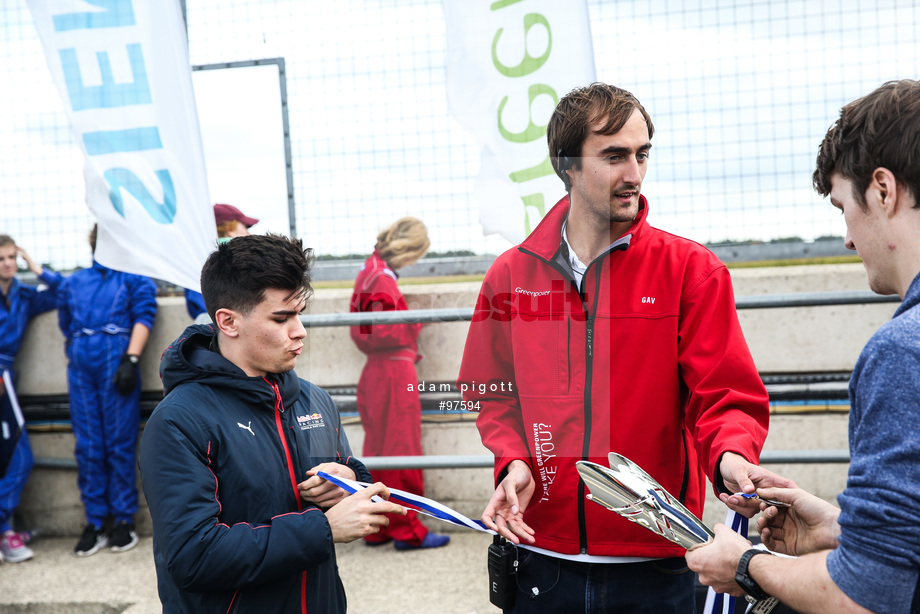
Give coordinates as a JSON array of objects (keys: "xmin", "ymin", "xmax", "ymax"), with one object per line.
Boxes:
[{"xmin": 575, "ymin": 452, "xmax": 777, "ymax": 614}]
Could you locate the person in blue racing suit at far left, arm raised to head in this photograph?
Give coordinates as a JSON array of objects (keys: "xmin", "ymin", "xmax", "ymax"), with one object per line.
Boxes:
[{"xmin": 0, "ymin": 235, "xmax": 62, "ymax": 563}]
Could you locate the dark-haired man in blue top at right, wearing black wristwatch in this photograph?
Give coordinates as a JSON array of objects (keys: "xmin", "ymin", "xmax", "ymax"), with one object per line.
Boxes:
[{"xmin": 687, "ymin": 79, "xmax": 920, "ymax": 614}]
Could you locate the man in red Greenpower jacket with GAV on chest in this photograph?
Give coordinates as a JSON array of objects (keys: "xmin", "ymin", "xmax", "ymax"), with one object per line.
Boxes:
[{"xmin": 459, "ymin": 83, "xmax": 787, "ymax": 613}]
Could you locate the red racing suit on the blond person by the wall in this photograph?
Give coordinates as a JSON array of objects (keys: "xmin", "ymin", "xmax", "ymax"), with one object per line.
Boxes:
[{"xmin": 350, "ymin": 251, "xmax": 428, "ymax": 545}]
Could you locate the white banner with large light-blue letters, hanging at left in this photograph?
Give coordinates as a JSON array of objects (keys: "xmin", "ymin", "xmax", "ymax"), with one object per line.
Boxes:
[{"xmin": 27, "ymin": 0, "xmax": 217, "ymax": 290}]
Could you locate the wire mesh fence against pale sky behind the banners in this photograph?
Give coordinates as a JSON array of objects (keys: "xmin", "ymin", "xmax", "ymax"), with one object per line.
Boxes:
[{"xmin": 0, "ymin": 0, "xmax": 920, "ymax": 269}]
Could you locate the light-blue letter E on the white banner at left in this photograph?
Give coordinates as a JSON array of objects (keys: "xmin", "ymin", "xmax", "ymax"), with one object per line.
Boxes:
[{"xmin": 58, "ymin": 43, "xmax": 151, "ymax": 111}]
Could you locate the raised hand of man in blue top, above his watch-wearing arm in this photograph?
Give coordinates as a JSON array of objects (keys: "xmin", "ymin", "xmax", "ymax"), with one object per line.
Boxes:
[{"xmin": 757, "ymin": 488, "xmax": 840, "ymax": 556}]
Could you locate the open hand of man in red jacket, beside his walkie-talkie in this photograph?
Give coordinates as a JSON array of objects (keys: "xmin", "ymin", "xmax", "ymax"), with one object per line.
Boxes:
[{"xmin": 482, "ymin": 460, "xmax": 536, "ymax": 544}]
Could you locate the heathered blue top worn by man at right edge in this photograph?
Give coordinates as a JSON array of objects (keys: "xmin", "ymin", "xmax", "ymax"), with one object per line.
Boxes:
[{"xmin": 827, "ymin": 275, "xmax": 920, "ymax": 612}]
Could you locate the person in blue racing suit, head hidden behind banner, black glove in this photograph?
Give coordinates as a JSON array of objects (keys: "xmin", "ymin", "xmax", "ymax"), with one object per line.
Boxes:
[{"xmin": 58, "ymin": 227, "xmax": 157, "ymax": 556}]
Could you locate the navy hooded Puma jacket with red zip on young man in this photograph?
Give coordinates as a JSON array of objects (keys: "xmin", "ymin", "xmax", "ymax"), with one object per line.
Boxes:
[{"xmin": 138, "ymin": 325, "xmax": 371, "ymax": 614}]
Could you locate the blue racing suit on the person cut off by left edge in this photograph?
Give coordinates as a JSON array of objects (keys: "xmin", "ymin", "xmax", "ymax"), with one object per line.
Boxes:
[{"xmin": 0, "ymin": 269, "xmax": 63, "ymax": 533}]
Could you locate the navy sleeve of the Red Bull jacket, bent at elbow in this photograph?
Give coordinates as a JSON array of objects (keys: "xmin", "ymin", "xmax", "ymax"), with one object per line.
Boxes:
[{"xmin": 138, "ymin": 404, "xmax": 333, "ymax": 592}]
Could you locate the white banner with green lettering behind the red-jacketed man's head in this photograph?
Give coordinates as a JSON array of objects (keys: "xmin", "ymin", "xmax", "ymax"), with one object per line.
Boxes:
[{"xmin": 443, "ymin": 0, "xmax": 596, "ymax": 243}]
